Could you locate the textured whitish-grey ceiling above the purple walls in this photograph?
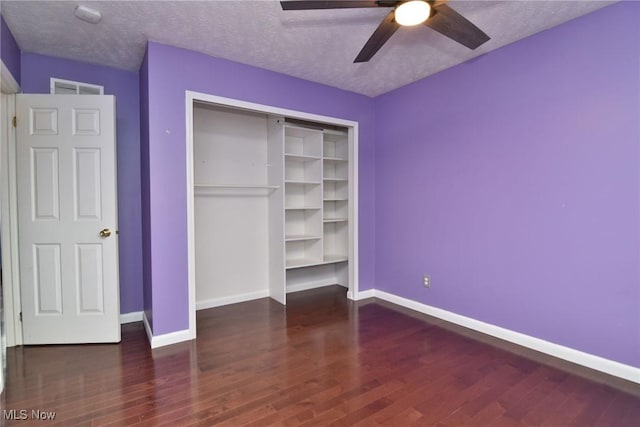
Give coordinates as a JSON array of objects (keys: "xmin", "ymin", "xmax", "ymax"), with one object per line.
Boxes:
[{"xmin": 0, "ymin": 0, "xmax": 615, "ymax": 96}]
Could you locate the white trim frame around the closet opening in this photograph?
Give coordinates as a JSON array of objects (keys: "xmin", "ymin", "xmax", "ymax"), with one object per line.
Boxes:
[{"xmin": 185, "ymin": 90, "xmax": 359, "ymax": 338}]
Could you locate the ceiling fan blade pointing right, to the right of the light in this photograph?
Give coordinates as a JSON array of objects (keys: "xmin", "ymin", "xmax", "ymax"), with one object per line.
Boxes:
[{"xmin": 424, "ymin": 4, "xmax": 491, "ymax": 49}]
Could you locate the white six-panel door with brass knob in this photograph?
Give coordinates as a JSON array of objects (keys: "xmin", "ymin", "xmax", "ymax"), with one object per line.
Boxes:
[{"xmin": 16, "ymin": 95, "xmax": 120, "ymax": 344}]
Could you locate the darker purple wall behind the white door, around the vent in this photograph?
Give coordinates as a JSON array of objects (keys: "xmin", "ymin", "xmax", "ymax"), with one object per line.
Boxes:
[{"xmin": 21, "ymin": 53, "xmax": 143, "ymax": 313}]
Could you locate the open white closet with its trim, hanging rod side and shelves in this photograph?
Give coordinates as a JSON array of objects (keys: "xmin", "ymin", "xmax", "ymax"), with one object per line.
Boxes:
[{"xmin": 186, "ymin": 92, "xmax": 358, "ymax": 338}]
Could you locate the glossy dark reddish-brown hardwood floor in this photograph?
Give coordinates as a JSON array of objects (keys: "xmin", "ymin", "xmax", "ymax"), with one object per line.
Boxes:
[{"xmin": 3, "ymin": 287, "xmax": 640, "ymax": 427}]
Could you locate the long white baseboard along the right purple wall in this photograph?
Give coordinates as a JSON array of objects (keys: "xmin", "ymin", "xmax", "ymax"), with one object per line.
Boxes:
[{"xmin": 372, "ymin": 290, "xmax": 640, "ymax": 384}]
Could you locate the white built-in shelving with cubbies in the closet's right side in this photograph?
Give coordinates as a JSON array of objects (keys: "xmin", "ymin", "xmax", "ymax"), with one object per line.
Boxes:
[{"xmin": 284, "ymin": 126, "xmax": 349, "ymax": 270}]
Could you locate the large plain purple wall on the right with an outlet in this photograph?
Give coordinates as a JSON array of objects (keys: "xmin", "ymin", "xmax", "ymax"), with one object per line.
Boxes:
[{"xmin": 375, "ymin": 2, "xmax": 640, "ymax": 366}]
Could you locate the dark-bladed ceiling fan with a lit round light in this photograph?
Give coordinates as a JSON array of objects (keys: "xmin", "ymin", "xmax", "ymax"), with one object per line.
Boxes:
[{"xmin": 280, "ymin": 0, "xmax": 490, "ymax": 62}]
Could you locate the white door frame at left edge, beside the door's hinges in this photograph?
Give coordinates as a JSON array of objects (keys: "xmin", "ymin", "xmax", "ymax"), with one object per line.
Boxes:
[{"xmin": 0, "ymin": 61, "xmax": 22, "ymax": 347}]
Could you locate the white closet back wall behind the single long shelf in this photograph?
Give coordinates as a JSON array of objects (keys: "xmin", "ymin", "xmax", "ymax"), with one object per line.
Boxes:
[{"xmin": 193, "ymin": 104, "xmax": 271, "ymax": 309}]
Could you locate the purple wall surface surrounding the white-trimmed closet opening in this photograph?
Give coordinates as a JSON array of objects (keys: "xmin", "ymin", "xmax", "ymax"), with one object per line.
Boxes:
[{"xmin": 143, "ymin": 43, "xmax": 374, "ymax": 335}]
